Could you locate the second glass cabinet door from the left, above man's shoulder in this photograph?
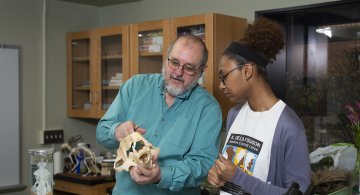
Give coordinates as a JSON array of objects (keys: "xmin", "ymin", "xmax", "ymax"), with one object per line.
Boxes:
[{"xmin": 94, "ymin": 26, "xmax": 129, "ymax": 118}]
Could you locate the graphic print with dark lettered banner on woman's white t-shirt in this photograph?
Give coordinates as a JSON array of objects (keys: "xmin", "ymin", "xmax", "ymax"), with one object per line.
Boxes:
[{"xmin": 220, "ymin": 133, "xmax": 263, "ymax": 195}]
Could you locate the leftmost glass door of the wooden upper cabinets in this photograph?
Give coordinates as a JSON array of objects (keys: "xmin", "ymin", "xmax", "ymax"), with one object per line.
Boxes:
[{"xmin": 68, "ymin": 32, "xmax": 92, "ymax": 117}]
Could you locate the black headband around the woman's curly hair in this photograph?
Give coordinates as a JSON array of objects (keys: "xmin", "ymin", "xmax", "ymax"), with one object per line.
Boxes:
[{"xmin": 225, "ymin": 42, "xmax": 269, "ymax": 67}]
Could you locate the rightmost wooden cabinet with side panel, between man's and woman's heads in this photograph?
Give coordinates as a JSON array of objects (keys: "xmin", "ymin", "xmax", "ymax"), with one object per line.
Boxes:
[{"xmin": 170, "ymin": 13, "xmax": 247, "ymax": 119}]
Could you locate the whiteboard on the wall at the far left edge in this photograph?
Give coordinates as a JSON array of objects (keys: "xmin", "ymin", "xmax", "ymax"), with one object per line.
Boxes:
[{"xmin": 0, "ymin": 47, "xmax": 21, "ymax": 192}]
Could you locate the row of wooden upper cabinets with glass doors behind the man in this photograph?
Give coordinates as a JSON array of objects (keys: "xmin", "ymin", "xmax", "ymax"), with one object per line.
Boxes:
[{"xmin": 67, "ymin": 13, "xmax": 247, "ymax": 118}]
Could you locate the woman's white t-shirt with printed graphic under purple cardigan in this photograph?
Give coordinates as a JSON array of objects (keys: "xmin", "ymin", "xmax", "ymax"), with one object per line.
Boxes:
[{"xmin": 220, "ymin": 100, "xmax": 286, "ymax": 195}]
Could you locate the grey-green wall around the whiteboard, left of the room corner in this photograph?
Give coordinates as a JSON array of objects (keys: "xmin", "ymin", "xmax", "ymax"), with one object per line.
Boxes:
[{"xmin": 0, "ymin": 0, "xmax": 42, "ymax": 193}]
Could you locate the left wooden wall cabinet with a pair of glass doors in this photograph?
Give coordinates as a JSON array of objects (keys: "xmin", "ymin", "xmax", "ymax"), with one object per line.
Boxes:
[{"xmin": 67, "ymin": 25, "xmax": 130, "ymax": 118}]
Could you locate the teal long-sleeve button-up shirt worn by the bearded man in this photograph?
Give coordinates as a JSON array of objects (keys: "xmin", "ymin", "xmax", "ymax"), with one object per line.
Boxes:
[{"xmin": 96, "ymin": 74, "xmax": 222, "ymax": 195}]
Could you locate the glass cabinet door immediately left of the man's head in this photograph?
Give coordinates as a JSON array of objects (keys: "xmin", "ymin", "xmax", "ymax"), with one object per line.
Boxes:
[{"xmin": 131, "ymin": 20, "xmax": 169, "ymax": 75}]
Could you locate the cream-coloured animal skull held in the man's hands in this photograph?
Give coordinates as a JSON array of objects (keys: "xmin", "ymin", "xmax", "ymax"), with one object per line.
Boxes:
[{"xmin": 114, "ymin": 132, "xmax": 160, "ymax": 172}]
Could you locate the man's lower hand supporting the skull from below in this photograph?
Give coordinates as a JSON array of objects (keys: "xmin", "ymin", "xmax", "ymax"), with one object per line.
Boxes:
[{"xmin": 130, "ymin": 155, "xmax": 161, "ymax": 184}]
